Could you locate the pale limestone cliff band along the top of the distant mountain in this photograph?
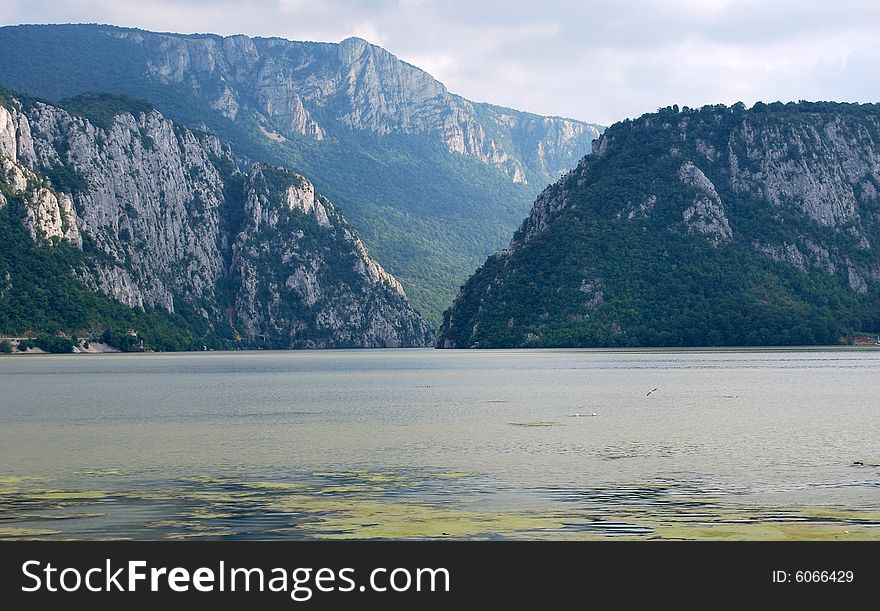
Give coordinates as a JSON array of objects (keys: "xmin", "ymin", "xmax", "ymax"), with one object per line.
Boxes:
[{"xmin": 101, "ymin": 27, "xmax": 601, "ymax": 183}]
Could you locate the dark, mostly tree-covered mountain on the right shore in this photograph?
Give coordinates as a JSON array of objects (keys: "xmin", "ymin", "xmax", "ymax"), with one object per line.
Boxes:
[{"xmin": 438, "ymin": 102, "xmax": 880, "ymax": 347}]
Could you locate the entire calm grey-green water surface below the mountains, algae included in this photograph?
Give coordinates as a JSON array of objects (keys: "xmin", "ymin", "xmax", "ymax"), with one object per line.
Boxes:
[{"xmin": 0, "ymin": 350, "xmax": 880, "ymax": 539}]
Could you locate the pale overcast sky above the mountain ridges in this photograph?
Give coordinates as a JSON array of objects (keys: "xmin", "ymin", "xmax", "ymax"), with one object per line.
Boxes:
[{"xmin": 0, "ymin": 0, "xmax": 880, "ymax": 125}]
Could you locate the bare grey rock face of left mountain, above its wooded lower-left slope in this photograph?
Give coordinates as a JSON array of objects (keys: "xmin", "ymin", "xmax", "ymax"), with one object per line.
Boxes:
[{"xmin": 0, "ymin": 93, "xmax": 430, "ymax": 347}]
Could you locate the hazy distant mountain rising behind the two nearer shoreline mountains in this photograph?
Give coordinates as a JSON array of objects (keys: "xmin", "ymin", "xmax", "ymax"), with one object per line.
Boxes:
[{"xmin": 0, "ymin": 25, "xmax": 601, "ymax": 322}]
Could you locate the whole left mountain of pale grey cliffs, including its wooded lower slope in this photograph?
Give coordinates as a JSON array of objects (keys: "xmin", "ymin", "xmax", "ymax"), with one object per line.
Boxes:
[{"xmin": 0, "ymin": 92, "xmax": 431, "ymax": 349}]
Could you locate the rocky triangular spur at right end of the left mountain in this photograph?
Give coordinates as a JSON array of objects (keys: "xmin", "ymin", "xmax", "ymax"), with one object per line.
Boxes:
[{"xmin": 230, "ymin": 165, "xmax": 430, "ymax": 348}]
